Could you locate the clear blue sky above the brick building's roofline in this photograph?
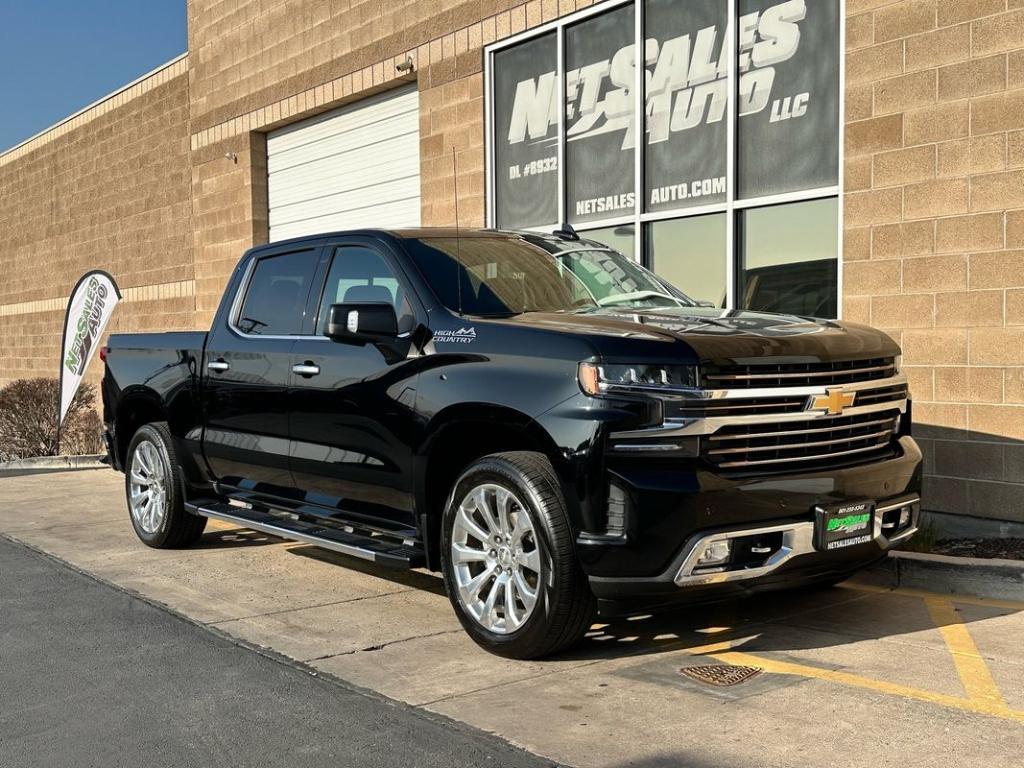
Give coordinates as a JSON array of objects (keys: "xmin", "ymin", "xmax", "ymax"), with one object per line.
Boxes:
[{"xmin": 0, "ymin": 0, "xmax": 188, "ymax": 152}]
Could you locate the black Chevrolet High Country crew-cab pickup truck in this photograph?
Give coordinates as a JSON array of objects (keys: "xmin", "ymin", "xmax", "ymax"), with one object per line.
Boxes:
[{"xmin": 102, "ymin": 229, "xmax": 921, "ymax": 657}]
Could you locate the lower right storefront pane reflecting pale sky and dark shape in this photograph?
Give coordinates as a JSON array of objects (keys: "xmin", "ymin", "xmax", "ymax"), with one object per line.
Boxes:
[{"xmin": 737, "ymin": 198, "xmax": 839, "ymax": 317}]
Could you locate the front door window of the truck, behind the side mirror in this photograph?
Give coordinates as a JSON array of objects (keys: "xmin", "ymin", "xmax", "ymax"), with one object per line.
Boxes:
[{"xmin": 317, "ymin": 246, "xmax": 413, "ymax": 334}]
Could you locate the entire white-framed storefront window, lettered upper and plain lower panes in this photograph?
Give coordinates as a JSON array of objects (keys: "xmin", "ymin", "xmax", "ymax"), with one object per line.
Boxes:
[{"xmin": 485, "ymin": 0, "xmax": 846, "ymax": 317}]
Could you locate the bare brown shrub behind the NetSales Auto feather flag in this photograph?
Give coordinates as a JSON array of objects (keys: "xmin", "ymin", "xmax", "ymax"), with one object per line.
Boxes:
[{"xmin": 0, "ymin": 379, "xmax": 102, "ymax": 461}]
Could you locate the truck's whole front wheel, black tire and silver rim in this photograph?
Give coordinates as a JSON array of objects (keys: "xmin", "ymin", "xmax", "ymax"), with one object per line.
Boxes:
[{"xmin": 441, "ymin": 452, "xmax": 596, "ymax": 658}]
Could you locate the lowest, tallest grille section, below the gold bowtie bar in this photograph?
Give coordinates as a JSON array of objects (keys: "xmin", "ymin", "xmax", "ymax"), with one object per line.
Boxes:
[{"xmin": 701, "ymin": 410, "xmax": 900, "ymax": 472}]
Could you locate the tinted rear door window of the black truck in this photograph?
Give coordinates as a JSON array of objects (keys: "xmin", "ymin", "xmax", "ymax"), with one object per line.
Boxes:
[{"xmin": 236, "ymin": 250, "xmax": 317, "ymax": 336}]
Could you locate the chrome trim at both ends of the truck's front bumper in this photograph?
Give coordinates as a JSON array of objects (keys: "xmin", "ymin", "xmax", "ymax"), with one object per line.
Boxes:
[{"xmin": 673, "ymin": 496, "xmax": 921, "ymax": 587}]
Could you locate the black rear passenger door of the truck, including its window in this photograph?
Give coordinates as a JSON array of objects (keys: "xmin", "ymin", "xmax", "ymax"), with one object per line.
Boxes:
[{"xmin": 203, "ymin": 242, "xmax": 322, "ymax": 497}]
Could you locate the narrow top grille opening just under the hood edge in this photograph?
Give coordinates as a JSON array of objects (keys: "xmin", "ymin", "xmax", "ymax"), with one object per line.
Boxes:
[{"xmin": 700, "ymin": 357, "xmax": 896, "ymax": 389}]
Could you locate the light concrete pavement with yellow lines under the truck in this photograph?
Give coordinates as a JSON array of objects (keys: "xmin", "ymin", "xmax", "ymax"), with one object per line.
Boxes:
[{"xmin": 0, "ymin": 470, "xmax": 1024, "ymax": 768}]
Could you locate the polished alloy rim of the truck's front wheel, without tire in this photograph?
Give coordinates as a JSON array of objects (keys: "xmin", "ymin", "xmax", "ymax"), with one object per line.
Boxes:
[{"xmin": 451, "ymin": 483, "xmax": 541, "ymax": 635}]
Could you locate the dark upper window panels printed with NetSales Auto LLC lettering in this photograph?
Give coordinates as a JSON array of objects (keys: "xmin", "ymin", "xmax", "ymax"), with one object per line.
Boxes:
[{"xmin": 494, "ymin": 0, "xmax": 839, "ymax": 225}]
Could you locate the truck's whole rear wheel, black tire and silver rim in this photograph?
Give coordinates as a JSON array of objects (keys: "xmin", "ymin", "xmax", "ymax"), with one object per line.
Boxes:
[{"xmin": 125, "ymin": 422, "xmax": 206, "ymax": 549}]
